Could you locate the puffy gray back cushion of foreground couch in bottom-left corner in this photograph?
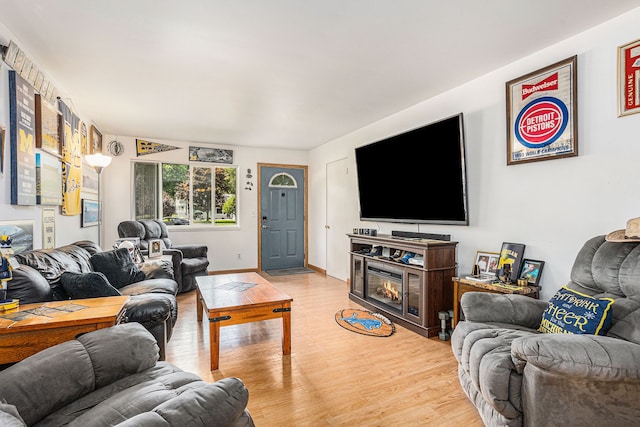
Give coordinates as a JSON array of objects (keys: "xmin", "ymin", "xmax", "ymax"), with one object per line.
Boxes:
[{"xmin": 0, "ymin": 323, "xmax": 158, "ymax": 425}]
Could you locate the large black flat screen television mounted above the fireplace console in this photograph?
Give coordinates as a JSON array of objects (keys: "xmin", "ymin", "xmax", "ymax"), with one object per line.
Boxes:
[{"xmin": 355, "ymin": 113, "xmax": 469, "ymax": 225}]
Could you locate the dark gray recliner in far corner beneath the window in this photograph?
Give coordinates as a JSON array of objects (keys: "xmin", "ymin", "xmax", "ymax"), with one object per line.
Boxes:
[{"xmin": 118, "ymin": 219, "xmax": 209, "ymax": 293}]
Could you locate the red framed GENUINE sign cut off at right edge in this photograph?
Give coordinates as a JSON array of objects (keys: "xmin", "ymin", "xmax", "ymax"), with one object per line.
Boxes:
[{"xmin": 618, "ymin": 40, "xmax": 640, "ymax": 116}]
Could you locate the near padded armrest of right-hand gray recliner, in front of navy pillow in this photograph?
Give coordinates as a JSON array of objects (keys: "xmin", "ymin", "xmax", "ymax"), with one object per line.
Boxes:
[{"xmin": 511, "ymin": 334, "xmax": 640, "ymax": 381}]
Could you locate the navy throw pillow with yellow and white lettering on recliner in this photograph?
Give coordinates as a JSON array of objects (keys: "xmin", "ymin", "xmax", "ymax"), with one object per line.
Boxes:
[{"xmin": 538, "ymin": 286, "xmax": 614, "ymax": 335}]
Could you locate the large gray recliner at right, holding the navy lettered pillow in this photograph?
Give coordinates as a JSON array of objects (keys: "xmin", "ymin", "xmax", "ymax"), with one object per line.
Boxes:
[{"xmin": 451, "ymin": 236, "xmax": 640, "ymax": 427}]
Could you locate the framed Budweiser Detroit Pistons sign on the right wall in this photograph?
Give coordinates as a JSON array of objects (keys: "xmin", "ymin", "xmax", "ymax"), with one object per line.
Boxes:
[{"xmin": 507, "ymin": 56, "xmax": 578, "ymax": 165}]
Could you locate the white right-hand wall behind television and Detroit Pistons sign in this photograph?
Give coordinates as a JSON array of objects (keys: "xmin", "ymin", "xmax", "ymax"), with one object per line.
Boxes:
[{"xmin": 309, "ymin": 9, "xmax": 640, "ymax": 299}]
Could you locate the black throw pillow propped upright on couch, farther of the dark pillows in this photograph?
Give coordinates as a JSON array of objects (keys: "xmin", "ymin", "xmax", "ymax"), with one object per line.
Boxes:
[{"xmin": 89, "ymin": 248, "xmax": 145, "ymax": 289}]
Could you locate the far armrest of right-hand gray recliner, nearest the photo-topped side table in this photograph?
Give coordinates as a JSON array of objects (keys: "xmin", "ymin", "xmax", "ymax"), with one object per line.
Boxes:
[{"xmin": 460, "ymin": 292, "xmax": 548, "ymax": 329}]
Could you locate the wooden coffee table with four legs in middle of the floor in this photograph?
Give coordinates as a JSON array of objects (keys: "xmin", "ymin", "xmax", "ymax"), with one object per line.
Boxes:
[{"xmin": 196, "ymin": 273, "xmax": 293, "ymax": 371}]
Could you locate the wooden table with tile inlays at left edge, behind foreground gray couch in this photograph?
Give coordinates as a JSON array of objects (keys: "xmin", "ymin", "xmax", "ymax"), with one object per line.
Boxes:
[{"xmin": 0, "ymin": 296, "xmax": 129, "ymax": 364}]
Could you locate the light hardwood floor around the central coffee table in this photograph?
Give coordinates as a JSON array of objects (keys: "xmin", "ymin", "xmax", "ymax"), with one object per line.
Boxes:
[{"xmin": 167, "ymin": 273, "xmax": 483, "ymax": 426}]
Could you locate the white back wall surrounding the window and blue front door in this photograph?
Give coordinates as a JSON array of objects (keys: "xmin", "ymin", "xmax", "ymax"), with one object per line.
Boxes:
[{"xmin": 102, "ymin": 135, "xmax": 308, "ymax": 271}]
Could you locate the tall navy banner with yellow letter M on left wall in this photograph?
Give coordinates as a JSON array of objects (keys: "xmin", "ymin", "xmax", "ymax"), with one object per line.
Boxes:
[{"xmin": 9, "ymin": 71, "xmax": 36, "ymax": 205}]
